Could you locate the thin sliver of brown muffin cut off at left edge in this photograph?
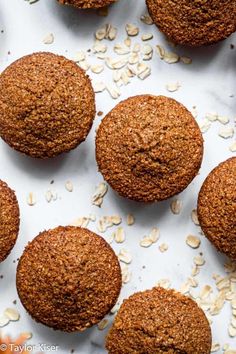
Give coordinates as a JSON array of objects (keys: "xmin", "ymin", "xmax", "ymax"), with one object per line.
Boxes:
[{"xmin": 0, "ymin": 180, "xmax": 20, "ymax": 262}]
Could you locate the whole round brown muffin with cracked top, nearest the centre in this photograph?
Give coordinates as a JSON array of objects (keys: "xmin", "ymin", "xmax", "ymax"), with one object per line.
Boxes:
[{"xmin": 96, "ymin": 95, "xmax": 203, "ymax": 202}]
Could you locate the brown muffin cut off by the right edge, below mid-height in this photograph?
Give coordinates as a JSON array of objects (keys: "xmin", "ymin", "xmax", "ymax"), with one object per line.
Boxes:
[{"xmin": 197, "ymin": 157, "xmax": 236, "ymax": 260}]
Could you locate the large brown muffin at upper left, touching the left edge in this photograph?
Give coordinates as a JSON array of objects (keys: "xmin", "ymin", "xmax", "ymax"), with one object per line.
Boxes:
[{"xmin": 0, "ymin": 53, "xmax": 95, "ymax": 158}]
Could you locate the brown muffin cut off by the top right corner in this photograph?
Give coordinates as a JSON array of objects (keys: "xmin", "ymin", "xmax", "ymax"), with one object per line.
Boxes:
[{"xmin": 146, "ymin": 0, "xmax": 236, "ymax": 46}]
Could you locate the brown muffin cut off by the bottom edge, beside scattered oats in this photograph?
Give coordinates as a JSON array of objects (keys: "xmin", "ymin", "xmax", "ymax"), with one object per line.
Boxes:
[{"xmin": 106, "ymin": 287, "xmax": 211, "ymax": 354}]
